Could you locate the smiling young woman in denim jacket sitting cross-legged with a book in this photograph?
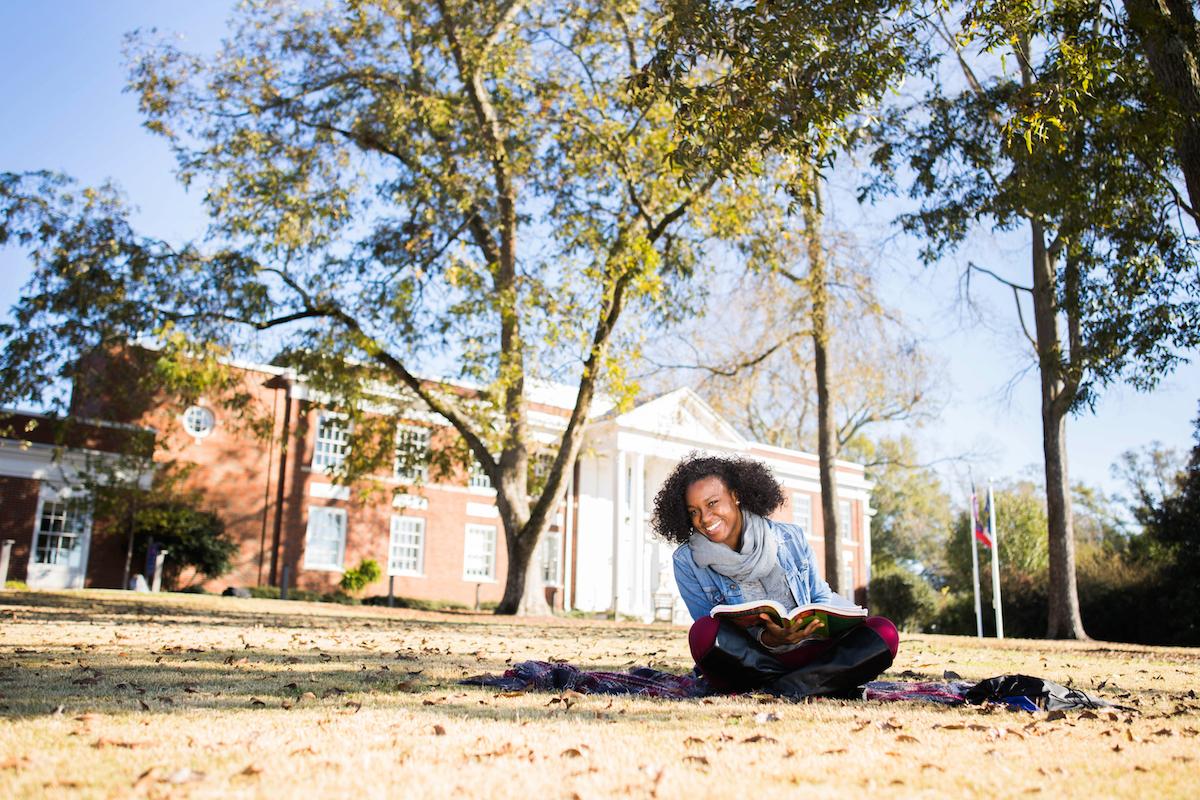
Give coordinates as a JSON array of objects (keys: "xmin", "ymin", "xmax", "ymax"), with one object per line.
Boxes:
[{"xmin": 653, "ymin": 453, "xmax": 899, "ymax": 697}]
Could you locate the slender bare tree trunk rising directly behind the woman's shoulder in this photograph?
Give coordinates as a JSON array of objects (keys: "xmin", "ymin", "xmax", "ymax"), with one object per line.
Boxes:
[{"xmin": 800, "ymin": 162, "xmax": 852, "ymax": 591}]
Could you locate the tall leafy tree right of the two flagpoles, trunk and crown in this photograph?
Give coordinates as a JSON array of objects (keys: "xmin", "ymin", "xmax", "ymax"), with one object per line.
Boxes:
[{"xmin": 877, "ymin": 0, "xmax": 1200, "ymax": 638}]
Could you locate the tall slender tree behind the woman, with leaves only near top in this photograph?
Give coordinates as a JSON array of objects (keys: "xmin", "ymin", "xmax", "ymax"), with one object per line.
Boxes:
[{"xmin": 646, "ymin": 0, "xmax": 912, "ymax": 591}]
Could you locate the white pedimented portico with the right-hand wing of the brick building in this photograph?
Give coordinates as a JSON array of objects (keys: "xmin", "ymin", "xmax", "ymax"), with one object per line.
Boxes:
[{"xmin": 568, "ymin": 389, "xmax": 870, "ymax": 622}]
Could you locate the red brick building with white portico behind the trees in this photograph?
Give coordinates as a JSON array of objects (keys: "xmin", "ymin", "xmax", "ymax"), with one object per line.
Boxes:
[{"xmin": 0, "ymin": 352, "xmax": 871, "ymax": 621}]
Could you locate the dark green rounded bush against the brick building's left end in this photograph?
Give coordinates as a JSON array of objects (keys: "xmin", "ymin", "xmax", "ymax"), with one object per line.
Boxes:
[{"xmin": 133, "ymin": 500, "xmax": 238, "ymax": 588}]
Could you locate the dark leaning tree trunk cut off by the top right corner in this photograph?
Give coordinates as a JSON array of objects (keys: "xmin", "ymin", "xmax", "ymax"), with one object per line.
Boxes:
[{"xmin": 1124, "ymin": 0, "xmax": 1200, "ymax": 224}]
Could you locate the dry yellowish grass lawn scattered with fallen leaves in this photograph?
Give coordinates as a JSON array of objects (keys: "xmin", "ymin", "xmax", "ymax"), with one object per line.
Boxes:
[{"xmin": 0, "ymin": 591, "xmax": 1200, "ymax": 800}]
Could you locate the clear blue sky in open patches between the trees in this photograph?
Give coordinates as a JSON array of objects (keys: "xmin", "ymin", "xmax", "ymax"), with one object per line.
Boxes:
[{"xmin": 0, "ymin": 0, "xmax": 1200, "ymax": 501}]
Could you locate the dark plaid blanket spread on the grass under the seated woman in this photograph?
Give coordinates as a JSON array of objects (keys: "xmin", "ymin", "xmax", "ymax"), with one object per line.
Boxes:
[{"xmin": 460, "ymin": 661, "xmax": 971, "ymax": 705}]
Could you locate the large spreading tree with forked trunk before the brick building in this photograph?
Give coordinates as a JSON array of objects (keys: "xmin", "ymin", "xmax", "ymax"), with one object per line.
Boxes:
[{"xmin": 0, "ymin": 0, "xmax": 737, "ymax": 613}]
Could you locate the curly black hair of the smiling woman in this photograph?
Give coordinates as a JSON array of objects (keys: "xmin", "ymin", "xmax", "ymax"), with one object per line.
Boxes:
[{"xmin": 650, "ymin": 452, "xmax": 785, "ymax": 545}]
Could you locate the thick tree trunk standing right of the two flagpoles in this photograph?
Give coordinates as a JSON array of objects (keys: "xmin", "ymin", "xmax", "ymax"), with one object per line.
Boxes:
[{"xmin": 1030, "ymin": 222, "xmax": 1088, "ymax": 639}]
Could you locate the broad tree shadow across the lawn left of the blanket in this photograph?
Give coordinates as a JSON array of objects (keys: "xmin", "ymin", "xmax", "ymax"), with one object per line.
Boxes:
[{"xmin": 0, "ymin": 648, "xmax": 710, "ymax": 724}]
